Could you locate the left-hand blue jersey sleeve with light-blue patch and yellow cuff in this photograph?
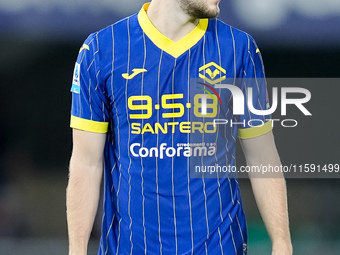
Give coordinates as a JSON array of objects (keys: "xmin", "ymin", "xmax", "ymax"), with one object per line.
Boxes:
[{"xmin": 70, "ymin": 34, "xmax": 109, "ymax": 133}]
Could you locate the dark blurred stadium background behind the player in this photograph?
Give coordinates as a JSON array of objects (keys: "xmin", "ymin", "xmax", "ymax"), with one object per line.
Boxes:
[{"xmin": 0, "ymin": 0, "xmax": 340, "ymax": 255}]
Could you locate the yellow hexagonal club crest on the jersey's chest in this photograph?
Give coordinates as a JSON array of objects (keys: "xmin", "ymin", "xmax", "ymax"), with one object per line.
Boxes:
[{"xmin": 198, "ymin": 62, "xmax": 227, "ymax": 84}]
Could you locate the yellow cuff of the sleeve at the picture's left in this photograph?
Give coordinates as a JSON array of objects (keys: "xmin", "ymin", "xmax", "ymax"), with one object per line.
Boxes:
[{"xmin": 70, "ymin": 115, "xmax": 109, "ymax": 134}]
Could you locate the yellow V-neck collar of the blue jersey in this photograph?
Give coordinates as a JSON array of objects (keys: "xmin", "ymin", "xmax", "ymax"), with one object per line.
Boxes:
[{"xmin": 138, "ymin": 3, "xmax": 209, "ymax": 58}]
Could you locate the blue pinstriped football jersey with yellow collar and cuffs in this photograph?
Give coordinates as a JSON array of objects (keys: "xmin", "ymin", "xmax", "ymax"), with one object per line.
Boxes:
[{"xmin": 71, "ymin": 4, "xmax": 271, "ymax": 255}]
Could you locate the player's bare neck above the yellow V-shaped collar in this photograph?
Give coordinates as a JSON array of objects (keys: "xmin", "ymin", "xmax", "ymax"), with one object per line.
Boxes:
[{"xmin": 147, "ymin": 0, "xmax": 199, "ymax": 42}]
